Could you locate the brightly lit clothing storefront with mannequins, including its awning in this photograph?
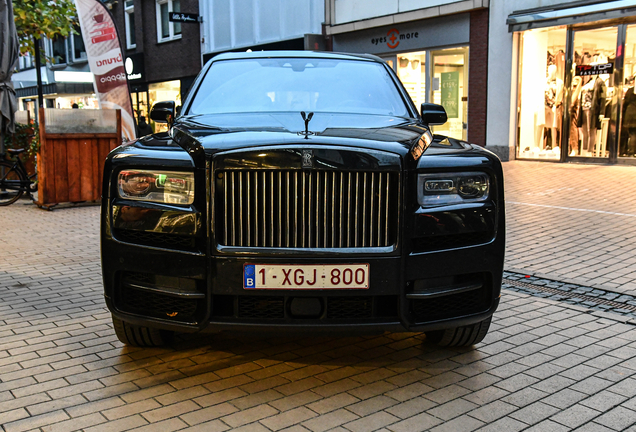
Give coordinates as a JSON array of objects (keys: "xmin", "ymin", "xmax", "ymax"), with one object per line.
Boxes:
[{"xmin": 508, "ymin": 1, "xmax": 636, "ymax": 164}]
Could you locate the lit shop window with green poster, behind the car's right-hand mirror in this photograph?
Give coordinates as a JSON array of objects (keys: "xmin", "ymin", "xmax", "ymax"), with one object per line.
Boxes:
[{"xmin": 431, "ymin": 47, "xmax": 468, "ymax": 140}]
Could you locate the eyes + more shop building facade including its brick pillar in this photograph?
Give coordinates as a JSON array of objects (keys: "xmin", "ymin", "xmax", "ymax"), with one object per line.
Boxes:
[{"xmin": 325, "ymin": 0, "xmax": 488, "ymax": 146}]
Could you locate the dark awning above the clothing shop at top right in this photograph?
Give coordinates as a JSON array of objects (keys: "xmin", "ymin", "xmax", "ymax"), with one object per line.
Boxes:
[{"xmin": 506, "ymin": 0, "xmax": 636, "ymax": 32}]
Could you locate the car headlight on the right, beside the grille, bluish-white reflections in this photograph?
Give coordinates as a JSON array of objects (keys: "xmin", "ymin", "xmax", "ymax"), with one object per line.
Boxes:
[{"xmin": 417, "ymin": 172, "xmax": 490, "ymax": 207}]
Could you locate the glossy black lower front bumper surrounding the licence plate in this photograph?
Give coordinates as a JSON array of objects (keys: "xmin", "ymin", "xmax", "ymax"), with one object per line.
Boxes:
[{"xmin": 102, "ymin": 231, "xmax": 502, "ymax": 332}]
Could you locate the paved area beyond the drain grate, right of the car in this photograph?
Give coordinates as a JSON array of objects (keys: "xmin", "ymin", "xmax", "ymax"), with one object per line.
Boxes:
[{"xmin": 504, "ymin": 161, "xmax": 636, "ymax": 294}]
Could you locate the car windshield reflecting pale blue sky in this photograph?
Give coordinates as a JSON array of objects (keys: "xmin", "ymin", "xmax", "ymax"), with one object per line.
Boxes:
[{"xmin": 188, "ymin": 58, "xmax": 409, "ymax": 117}]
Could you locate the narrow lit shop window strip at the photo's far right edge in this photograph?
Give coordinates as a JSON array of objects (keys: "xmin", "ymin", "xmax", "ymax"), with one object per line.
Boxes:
[{"xmin": 618, "ymin": 25, "xmax": 636, "ymax": 158}]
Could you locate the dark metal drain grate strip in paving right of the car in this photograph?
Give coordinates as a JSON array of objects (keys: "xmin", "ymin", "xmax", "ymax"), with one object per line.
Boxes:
[{"xmin": 502, "ymin": 272, "xmax": 636, "ymax": 317}]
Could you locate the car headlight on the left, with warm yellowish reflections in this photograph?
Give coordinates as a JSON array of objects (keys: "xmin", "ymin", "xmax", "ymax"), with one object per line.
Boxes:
[{"xmin": 117, "ymin": 170, "xmax": 194, "ymax": 204}]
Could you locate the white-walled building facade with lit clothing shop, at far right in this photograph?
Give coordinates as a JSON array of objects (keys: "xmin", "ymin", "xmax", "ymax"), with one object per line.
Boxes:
[{"xmin": 487, "ymin": 0, "xmax": 636, "ymax": 164}]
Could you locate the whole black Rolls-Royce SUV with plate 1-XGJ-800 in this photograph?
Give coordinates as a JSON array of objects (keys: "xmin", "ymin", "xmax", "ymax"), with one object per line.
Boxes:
[{"xmin": 101, "ymin": 51, "xmax": 505, "ymax": 346}]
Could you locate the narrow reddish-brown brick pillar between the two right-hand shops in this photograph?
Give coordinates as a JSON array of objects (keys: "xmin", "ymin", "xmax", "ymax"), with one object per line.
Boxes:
[{"xmin": 468, "ymin": 9, "xmax": 488, "ymax": 146}]
